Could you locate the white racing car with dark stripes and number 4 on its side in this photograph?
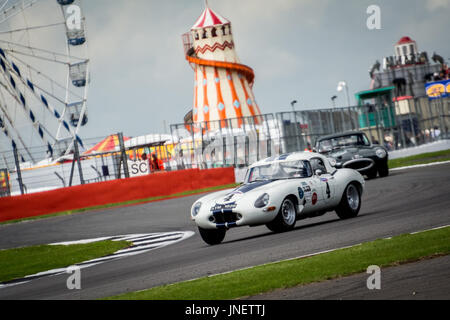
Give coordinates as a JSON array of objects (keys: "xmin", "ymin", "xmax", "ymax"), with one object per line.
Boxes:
[{"xmin": 191, "ymin": 152, "xmax": 365, "ymax": 245}]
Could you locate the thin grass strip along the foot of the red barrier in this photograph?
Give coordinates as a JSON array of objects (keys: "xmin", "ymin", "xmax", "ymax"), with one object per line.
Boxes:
[{"xmin": 0, "ymin": 184, "xmax": 237, "ymax": 226}]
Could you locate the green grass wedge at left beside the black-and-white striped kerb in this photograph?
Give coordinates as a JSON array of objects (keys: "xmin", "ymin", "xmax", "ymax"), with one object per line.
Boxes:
[{"xmin": 0, "ymin": 241, "xmax": 130, "ymax": 282}]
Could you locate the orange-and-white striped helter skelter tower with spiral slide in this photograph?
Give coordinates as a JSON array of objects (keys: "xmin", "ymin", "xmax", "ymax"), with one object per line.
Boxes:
[{"xmin": 183, "ymin": 1, "xmax": 262, "ymax": 130}]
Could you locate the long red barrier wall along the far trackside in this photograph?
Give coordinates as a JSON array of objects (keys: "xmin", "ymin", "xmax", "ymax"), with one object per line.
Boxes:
[{"xmin": 0, "ymin": 168, "xmax": 235, "ymax": 222}]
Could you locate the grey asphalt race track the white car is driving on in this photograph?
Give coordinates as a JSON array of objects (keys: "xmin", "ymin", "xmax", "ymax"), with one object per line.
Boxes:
[{"xmin": 0, "ymin": 164, "xmax": 450, "ymax": 299}]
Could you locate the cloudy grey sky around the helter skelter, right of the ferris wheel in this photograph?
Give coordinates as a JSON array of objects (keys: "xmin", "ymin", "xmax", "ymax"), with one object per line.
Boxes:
[{"xmin": 78, "ymin": 0, "xmax": 450, "ymax": 137}]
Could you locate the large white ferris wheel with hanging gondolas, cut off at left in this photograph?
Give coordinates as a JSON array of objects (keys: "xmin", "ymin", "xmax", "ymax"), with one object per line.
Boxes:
[{"xmin": 0, "ymin": 0, "xmax": 89, "ymax": 163}]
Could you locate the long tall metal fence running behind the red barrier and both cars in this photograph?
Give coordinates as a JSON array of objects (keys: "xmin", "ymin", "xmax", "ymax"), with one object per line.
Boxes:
[{"xmin": 0, "ymin": 97, "xmax": 450, "ymax": 196}]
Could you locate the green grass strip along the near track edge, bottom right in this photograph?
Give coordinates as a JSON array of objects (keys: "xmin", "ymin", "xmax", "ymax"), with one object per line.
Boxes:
[{"xmin": 109, "ymin": 227, "xmax": 450, "ymax": 300}]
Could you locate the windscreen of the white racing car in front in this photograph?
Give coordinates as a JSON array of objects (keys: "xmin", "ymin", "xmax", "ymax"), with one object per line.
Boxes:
[{"xmin": 245, "ymin": 160, "xmax": 312, "ymax": 183}]
